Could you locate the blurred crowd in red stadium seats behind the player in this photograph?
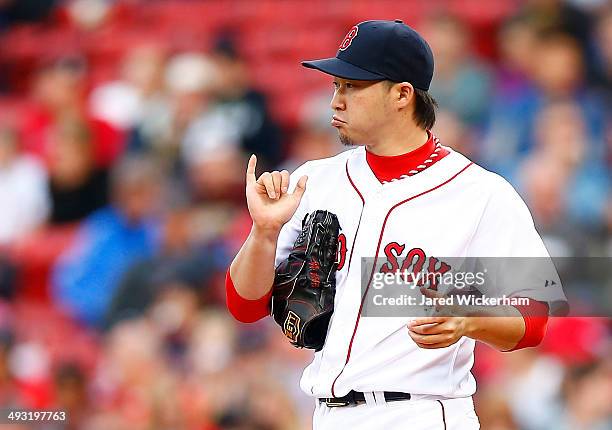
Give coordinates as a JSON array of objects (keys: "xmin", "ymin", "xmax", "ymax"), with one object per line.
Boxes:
[{"xmin": 0, "ymin": 0, "xmax": 612, "ymax": 430}]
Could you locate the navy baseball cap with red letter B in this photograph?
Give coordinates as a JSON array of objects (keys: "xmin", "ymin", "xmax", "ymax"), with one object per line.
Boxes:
[{"xmin": 302, "ymin": 19, "xmax": 434, "ymax": 91}]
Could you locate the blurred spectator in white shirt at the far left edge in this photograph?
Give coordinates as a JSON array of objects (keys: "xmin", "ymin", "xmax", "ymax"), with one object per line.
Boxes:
[{"xmin": 0, "ymin": 128, "xmax": 49, "ymax": 245}]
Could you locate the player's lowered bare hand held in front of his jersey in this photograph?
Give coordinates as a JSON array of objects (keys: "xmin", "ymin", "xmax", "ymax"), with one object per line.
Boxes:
[{"xmin": 408, "ymin": 288, "xmax": 468, "ymax": 349}]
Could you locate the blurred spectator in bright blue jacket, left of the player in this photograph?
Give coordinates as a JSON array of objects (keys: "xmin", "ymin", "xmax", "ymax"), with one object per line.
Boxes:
[{"xmin": 52, "ymin": 159, "xmax": 160, "ymax": 327}]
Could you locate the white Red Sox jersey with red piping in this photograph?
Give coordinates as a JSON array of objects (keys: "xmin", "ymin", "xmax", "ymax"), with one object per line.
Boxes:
[{"xmin": 276, "ymin": 147, "xmax": 560, "ymax": 398}]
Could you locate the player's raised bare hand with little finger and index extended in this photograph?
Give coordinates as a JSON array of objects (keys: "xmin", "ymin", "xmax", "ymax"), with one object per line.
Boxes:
[{"xmin": 246, "ymin": 154, "xmax": 308, "ymax": 231}]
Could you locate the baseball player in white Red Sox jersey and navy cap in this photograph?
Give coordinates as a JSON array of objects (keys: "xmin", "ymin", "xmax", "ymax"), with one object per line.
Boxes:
[{"xmin": 226, "ymin": 20, "xmax": 560, "ymax": 430}]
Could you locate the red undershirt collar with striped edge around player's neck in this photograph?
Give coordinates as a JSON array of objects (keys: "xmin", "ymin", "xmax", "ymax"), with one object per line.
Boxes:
[{"xmin": 366, "ymin": 131, "xmax": 448, "ymax": 183}]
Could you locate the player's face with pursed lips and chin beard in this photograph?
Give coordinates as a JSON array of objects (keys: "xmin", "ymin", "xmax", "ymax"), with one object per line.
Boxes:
[{"xmin": 331, "ymin": 78, "xmax": 389, "ymax": 145}]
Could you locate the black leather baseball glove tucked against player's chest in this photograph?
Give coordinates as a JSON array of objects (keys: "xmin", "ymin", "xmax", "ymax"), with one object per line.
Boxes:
[{"xmin": 272, "ymin": 210, "xmax": 340, "ymax": 351}]
